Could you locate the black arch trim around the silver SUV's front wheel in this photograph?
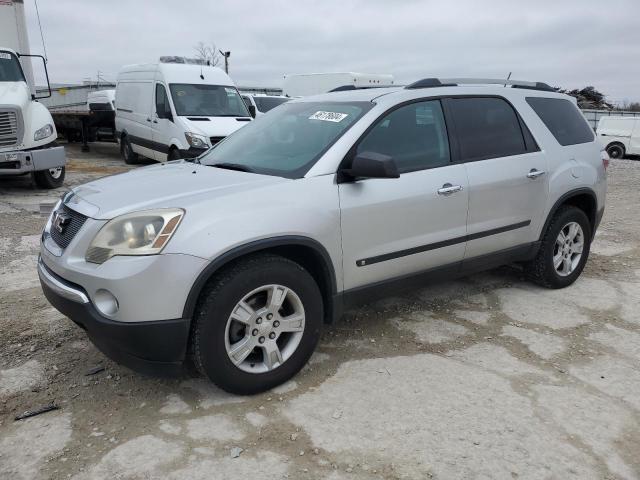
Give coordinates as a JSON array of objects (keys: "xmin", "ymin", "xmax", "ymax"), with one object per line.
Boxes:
[{"xmin": 183, "ymin": 235, "xmax": 339, "ymax": 318}]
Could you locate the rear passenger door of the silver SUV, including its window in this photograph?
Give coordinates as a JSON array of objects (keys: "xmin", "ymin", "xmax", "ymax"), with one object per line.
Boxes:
[{"xmin": 446, "ymin": 97, "xmax": 549, "ymax": 259}]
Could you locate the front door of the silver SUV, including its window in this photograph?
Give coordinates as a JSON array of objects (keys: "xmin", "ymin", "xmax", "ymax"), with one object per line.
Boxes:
[{"xmin": 339, "ymin": 100, "xmax": 468, "ymax": 289}]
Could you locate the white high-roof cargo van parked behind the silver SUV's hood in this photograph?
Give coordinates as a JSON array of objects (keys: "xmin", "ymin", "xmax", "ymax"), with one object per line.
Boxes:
[{"xmin": 116, "ymin": 57, "xmax": 251, "ymax": 164}]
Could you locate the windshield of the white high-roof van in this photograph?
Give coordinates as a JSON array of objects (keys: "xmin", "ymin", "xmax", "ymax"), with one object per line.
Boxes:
[{"xmin": 169, "ymin": 83, "xmax": 249, "ymax": 117}]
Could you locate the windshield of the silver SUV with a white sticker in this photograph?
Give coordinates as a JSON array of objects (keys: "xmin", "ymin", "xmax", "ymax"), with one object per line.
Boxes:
[{"xmin": 200, "ymin": 102, "xmax": 373, "ymax": 178}]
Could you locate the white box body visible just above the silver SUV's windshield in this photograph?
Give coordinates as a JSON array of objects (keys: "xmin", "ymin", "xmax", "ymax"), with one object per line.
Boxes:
[{"xmin": 282, "ymin": 72, "xmax": 395, "ymax": 97}]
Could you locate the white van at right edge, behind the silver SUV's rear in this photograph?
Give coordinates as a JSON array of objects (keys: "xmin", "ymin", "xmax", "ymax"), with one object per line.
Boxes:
[{"xmin": 596, "ymin": 117, "xmax": 640, "ymax": 158}]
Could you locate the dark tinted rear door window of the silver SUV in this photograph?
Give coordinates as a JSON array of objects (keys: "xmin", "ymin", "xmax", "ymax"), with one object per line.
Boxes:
[{"xmin": 449, "ymin": 97, "xmax": 527, "ymax": 162}]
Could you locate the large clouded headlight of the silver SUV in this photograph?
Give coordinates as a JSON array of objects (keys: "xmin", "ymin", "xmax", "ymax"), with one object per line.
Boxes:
[{"xmin": 85, "ymin": 208, "xmax": 184, "ymax": 264}]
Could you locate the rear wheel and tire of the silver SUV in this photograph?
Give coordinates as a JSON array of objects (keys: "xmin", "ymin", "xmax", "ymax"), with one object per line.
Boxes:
[{"xmin": 525, "ymin": 205, "xmax": 592, "ymax": 288}]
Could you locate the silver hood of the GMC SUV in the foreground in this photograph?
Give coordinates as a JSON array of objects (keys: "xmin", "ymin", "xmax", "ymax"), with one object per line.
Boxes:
[{"xmin": 64, "ymin": 160, "xmax": 288, "ymax": 220}]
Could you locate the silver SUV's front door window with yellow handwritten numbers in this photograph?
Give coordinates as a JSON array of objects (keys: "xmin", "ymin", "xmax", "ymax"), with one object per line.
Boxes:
[{"xmin": 356, "ymin": 100, "xmax": 450, "ymax": 173}]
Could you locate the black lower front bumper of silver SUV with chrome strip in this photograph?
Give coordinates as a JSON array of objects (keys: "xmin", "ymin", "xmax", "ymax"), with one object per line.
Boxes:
[{"xmin": 38, "ymin": 259, "xmax": 190, "ymax": 376}]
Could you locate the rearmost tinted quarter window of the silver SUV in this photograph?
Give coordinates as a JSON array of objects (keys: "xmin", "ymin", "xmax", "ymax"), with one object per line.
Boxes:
[{"xmin": 527, "ymin": 97, "xmax": 594, "ymax": 146}]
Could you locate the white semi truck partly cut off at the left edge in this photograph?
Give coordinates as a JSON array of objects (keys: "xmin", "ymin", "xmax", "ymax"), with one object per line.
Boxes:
[{"xmin": 0, "ymin": 0, "xmax": 65, "ymax": 188}]
